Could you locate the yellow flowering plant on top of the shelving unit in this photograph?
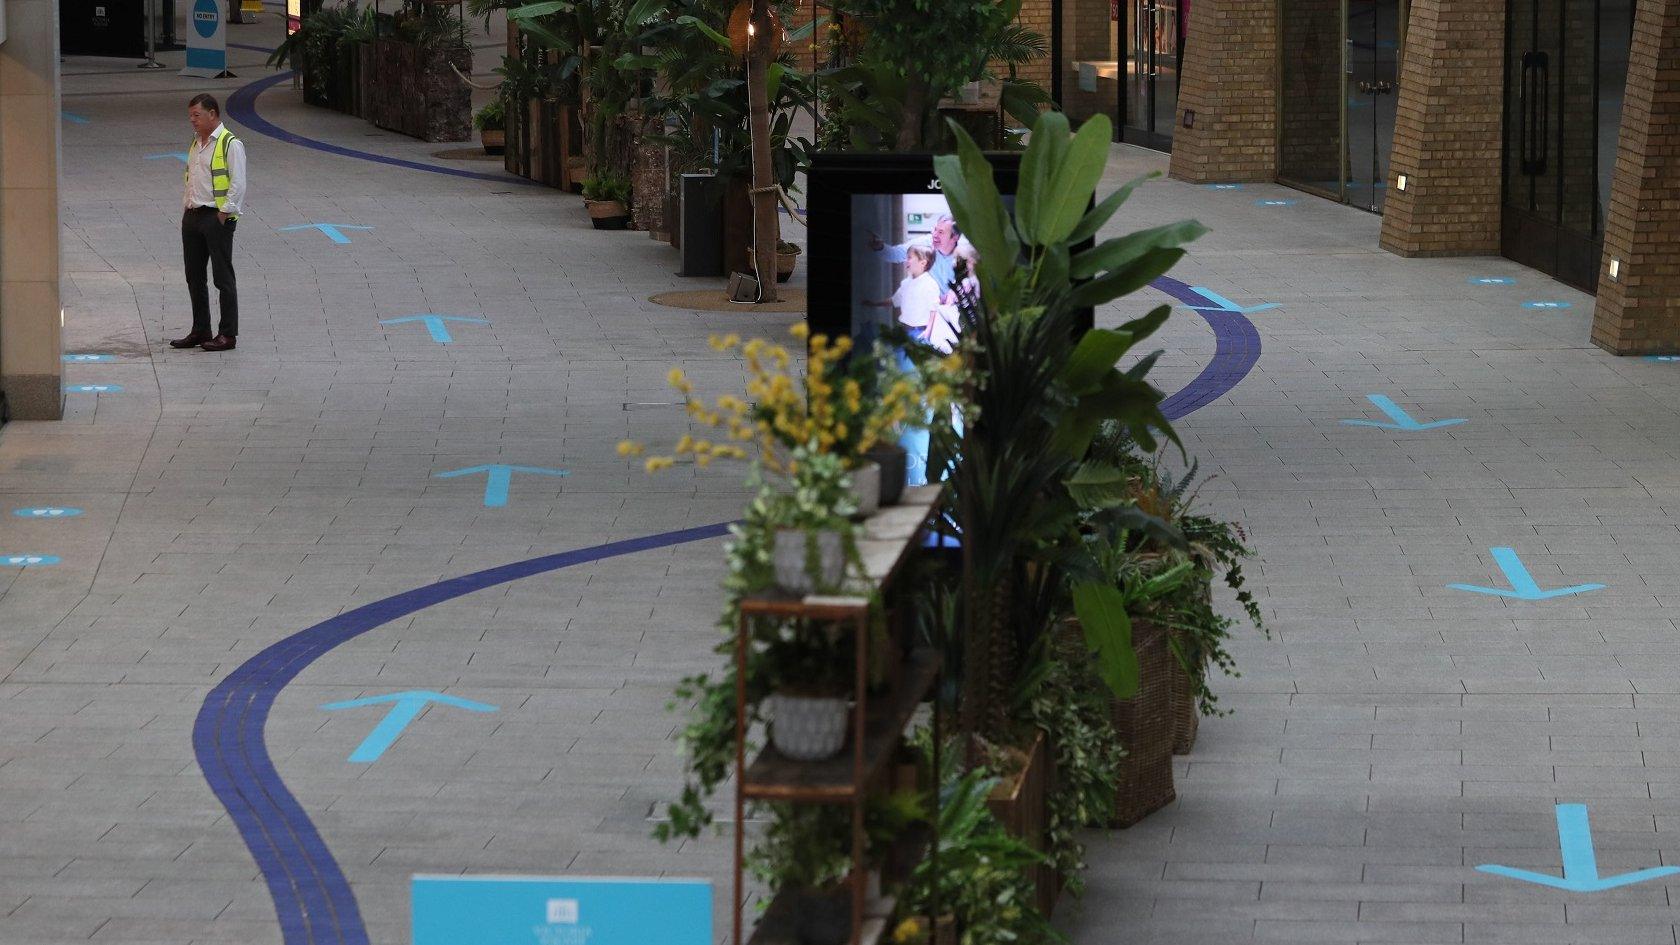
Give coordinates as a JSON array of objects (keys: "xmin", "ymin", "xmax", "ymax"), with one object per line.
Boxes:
[{"xmin": 618, "ymin": 325, "xmax": 961, "ymax": 474}]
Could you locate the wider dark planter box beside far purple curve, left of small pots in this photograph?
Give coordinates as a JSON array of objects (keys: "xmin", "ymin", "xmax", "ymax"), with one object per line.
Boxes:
[{"xmin": 365, "ymin": 39, "xmax": 472, "ymax": 141}]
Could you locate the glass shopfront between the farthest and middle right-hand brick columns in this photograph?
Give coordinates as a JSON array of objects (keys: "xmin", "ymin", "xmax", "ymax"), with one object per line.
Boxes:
[{"xmin": 1278, "ymin": 0, "xmax": 1406, "ymax": 212}]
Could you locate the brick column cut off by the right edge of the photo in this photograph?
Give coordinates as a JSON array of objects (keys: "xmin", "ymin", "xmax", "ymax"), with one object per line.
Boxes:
[{"xmin": 1593, "ymin": 0, "xmax": 1680, "ymax": 355}]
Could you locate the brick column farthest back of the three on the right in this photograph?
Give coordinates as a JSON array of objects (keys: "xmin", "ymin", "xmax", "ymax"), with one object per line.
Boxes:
[{"xmin": 1171, "ymin": 0, "xmax": 1270, "ymax": 183}]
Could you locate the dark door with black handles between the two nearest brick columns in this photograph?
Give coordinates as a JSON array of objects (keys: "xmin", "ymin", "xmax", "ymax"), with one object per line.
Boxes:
[{"xmin": 1500, "ymin": 0, "xmax": 1633, "ymax": 291}]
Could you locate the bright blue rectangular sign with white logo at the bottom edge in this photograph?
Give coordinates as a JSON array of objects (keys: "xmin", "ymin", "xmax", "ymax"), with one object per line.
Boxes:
[{"xmin": 420, "ymin": 876, "xmax": 712, "ymax": 945}]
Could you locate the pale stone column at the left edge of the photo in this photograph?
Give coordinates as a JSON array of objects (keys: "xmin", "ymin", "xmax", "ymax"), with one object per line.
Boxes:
[{"xmin": 0, "ymin": 0, "xmax": 64, "ymax": 420}]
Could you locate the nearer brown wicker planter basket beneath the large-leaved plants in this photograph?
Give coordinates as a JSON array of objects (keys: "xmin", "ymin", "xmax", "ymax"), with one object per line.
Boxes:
[{"xmin": 1109, "ymin": 620, "xmax": 1178, "ymax": 827}]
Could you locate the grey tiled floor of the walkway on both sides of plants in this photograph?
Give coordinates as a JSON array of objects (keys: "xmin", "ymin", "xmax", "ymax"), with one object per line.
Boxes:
[{"xmin": 0, "ymin": 18, "xmax": 1680, "ymax": 945}]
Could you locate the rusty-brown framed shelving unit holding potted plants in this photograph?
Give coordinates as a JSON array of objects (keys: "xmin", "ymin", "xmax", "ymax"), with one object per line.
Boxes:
[{"xmin": 732, "ymin": 486, "xmax": 944, "ymax": 945}]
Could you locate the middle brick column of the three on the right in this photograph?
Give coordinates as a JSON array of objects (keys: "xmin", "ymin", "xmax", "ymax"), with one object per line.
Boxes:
[{"xmin": 1381, "ymin": 0, "xmax": 1505, "ymax": 256}]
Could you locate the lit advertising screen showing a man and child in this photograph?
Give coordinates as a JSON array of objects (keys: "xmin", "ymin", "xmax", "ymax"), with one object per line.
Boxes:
[{"xmin": 852, "ymin": 193, "xmax": 979, "ymax": 486}]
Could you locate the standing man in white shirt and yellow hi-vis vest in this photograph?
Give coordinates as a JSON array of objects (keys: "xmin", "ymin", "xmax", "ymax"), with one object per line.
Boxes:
[{"xmin": 170, "ymin": 94, "xmax": 245, "ymax": 351}]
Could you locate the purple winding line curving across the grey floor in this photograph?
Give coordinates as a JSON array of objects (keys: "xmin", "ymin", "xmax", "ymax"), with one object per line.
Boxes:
[{"xmin": 193, "ymin": 60, "xmax": 1260, "ymax": 945}]
